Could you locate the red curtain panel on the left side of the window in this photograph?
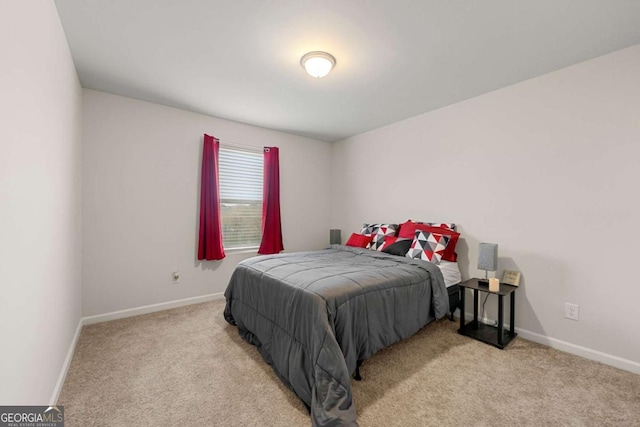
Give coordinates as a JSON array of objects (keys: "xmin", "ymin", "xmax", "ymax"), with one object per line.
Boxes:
[{"xmin": 198, "ymin": 134, "xmax": 225, "ymax": 261}]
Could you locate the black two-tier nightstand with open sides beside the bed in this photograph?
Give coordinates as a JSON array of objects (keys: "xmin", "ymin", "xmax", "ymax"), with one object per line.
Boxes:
[{"xmin": 458, "ymin": 279, "xmax": 518, "ymax": 349}]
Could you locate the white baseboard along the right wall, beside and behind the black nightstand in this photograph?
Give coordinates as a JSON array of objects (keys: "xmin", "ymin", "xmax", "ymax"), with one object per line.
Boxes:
[{"xmin": 465, "ymin": 312, "xmax": 640, "ymax": 374}]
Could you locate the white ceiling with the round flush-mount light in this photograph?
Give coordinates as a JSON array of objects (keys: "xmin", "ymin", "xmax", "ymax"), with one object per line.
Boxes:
[{"xmin": 56, "ymin": 0, "xmax": 640, "ymax": 141}]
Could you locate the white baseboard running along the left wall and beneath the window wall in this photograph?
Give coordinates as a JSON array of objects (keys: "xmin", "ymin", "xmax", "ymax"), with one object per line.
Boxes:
[{"xmin": 51, "ymin": 292, "xmax": 224, "ymax": 405}]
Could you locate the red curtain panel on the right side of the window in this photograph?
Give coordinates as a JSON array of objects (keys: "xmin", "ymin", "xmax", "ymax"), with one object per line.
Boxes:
[{"xmin": 258, "ymin": 147, "xmax": 284, "ymax": 255}]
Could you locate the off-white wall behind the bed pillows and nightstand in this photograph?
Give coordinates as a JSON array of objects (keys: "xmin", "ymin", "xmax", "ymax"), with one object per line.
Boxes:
[{"xmin": 331, "ymin": 46, "xmax": 640, "ymax": 372}]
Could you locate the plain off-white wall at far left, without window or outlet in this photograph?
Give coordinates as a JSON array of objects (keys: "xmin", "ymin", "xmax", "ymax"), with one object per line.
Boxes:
[{"xmin": 0, "ymin": 0, "xmax": 82, "ymax": 405}]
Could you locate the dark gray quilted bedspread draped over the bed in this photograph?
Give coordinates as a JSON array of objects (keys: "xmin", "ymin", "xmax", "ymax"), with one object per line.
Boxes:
[{"xmin": 224, "ymin": 245, "xmax": 449, "ymax": 426}]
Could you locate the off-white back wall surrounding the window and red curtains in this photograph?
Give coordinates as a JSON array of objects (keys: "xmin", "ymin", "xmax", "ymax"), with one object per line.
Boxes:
[{"xmin": 83, "ymin": 90, "xmax": 331, "ymax": 316}]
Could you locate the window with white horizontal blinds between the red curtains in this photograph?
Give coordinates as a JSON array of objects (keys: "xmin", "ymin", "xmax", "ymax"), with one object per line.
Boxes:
[{"xmin": 218, "ymin": 146, "xmax": 263, "ymax": 249}]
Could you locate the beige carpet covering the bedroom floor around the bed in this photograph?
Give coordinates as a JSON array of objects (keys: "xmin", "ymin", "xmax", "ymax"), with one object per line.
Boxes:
[{"xmin": 58, "ymin": 301, "xmax": 640, "ymax": 427}]
